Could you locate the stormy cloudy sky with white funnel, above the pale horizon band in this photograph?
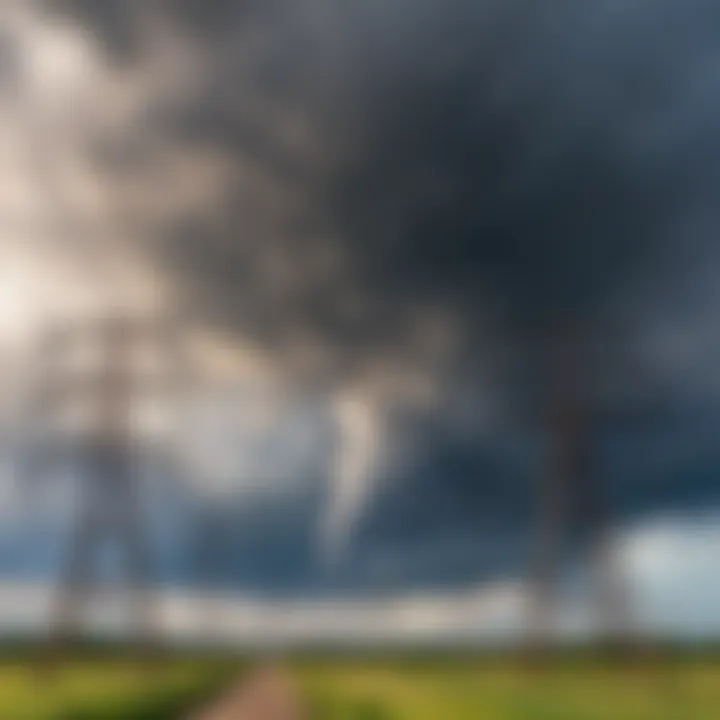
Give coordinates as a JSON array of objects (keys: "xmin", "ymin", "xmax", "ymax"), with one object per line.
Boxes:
[{"xmin": 0, "ymin": 0, "xmax": 720, "ymax": 640}]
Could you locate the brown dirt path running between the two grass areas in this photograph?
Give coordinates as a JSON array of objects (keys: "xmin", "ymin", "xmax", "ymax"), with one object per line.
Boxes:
[{"xmin": 188, "ymin": 666, "xmax": 308, "ymax": 720}]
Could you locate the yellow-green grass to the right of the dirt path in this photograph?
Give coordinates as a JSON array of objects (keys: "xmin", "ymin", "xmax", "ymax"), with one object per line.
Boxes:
[{"xmin": 298, "ymin": 659, "xmax": 720, "ymax": 720}]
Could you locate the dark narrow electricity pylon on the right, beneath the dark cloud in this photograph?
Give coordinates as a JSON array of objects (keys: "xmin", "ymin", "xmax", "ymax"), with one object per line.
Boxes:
[{"xmin": 528, "ymin": 327, "xmax": 633, "ymax": 651}]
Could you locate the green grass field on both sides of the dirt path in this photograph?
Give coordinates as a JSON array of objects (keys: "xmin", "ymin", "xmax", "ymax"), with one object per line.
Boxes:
[{"xmin": 0, "ymin": 656, "xmax": 720, "ymax": 720}]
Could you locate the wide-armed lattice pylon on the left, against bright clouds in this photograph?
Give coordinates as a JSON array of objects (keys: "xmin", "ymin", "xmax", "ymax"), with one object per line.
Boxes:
[{"xmin": 31, "ymin": 313, "xmax": 184, "ymax": 644}]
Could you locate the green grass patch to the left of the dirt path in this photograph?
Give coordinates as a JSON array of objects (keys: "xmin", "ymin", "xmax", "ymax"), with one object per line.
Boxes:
[{"xmin": 0, "ymin": 657, "xmax": 237, "ymax": 720}]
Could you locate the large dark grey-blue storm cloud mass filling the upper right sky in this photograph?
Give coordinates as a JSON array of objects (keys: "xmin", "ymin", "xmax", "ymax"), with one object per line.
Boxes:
[{"xmin": 46, "ymin": 0, "xmax": 718, "ymax": 390}]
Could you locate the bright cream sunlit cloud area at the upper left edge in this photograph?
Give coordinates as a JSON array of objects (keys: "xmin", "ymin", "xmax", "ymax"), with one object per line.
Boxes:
[{"xmin": 0, "ymin": 0, "xmax": 170, "ymax": 335}]
